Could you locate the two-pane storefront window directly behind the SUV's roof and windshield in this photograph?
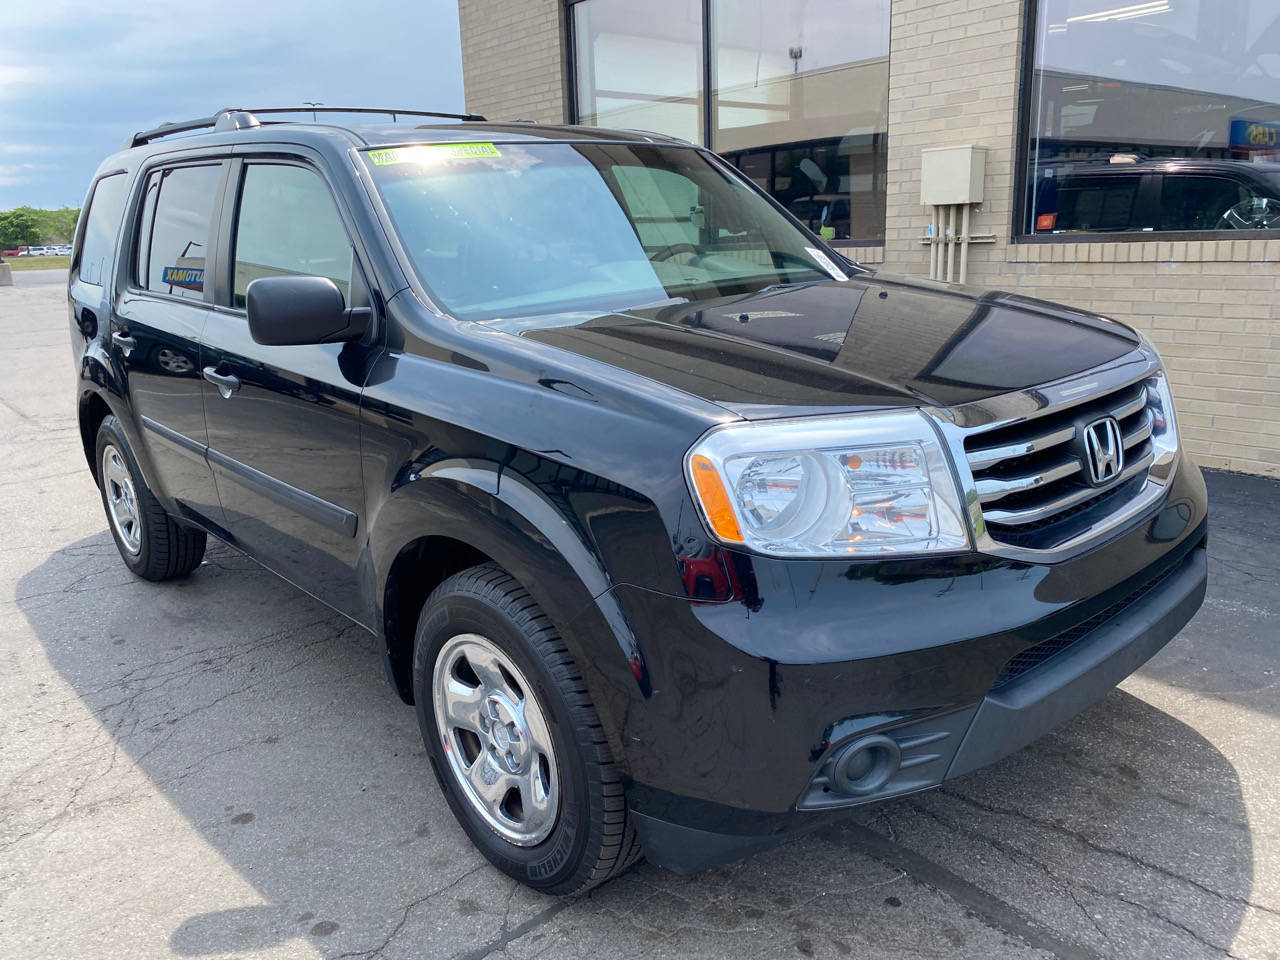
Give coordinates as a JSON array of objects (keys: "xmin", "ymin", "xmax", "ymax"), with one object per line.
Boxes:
[{"xmin": 572, "ymin": 0, "xmax": 890, "ymax": 243}]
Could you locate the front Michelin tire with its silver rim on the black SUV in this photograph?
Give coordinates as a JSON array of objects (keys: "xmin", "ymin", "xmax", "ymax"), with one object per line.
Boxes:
[{"xmin": 413, "ymin": 563, "xmax": 640, "ymax": 895}]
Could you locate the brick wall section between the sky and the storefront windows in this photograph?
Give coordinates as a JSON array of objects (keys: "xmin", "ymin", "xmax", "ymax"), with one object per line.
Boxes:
[{"xmin": 458, "ymin": 0, "xmax": 566, "ymax": 123}]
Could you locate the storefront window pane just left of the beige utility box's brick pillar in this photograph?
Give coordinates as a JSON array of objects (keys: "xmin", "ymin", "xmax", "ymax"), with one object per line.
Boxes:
[{"xmin": 712, "ymin": 0, "xmax": 890, "ymax": 243}]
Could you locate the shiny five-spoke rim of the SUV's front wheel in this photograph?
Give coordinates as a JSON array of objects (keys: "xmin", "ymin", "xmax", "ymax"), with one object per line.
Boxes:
[{"xmin": 431, "ymin": 634, "xmax": 559, "ymax": 846}]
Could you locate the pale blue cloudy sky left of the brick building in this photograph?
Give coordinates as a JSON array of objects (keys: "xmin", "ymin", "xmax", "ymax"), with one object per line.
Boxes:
[{"xmin": 0, "ymin": 0, "xmax": 463, "ymax": 210}]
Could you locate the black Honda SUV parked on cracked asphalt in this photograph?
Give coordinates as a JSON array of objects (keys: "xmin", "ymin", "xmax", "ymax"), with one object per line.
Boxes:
[{"xmin": 68, "ymin": 110, "xmax": 1206, "ymax": 893}]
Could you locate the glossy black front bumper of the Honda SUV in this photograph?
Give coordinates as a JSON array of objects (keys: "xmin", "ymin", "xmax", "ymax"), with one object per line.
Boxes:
[{"xmin": 604, "ymin": 461, "xmax": 1207, "ymax": 872}]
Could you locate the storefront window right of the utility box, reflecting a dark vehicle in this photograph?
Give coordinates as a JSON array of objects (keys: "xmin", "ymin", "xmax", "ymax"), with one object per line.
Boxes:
[{"xmin": 1021, "ymin": 0, "xmax": 1280, "ymax": 236}]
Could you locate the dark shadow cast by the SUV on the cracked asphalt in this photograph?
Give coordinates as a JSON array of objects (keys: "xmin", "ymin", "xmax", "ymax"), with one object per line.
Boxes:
[{"xmin": 17, "ymin": 532, "xmax": 1253, "ymax": 957}]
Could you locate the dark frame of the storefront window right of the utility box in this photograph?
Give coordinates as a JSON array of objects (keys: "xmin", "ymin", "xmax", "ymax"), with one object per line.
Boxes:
[{"xmin": 1009, "ymin": 0, "xmax": 1280, "ymax": 243}]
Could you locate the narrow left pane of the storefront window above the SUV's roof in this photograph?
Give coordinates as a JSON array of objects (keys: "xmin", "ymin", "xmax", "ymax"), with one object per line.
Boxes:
[{"xmin": 572, "ymin": 0, "xmax": 704, "ymax": 143}]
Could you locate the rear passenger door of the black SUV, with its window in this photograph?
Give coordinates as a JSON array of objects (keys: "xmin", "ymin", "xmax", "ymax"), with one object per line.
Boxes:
[{"xmin": 108, "ymin": 157, "xmax": 228, "ymax": 524}]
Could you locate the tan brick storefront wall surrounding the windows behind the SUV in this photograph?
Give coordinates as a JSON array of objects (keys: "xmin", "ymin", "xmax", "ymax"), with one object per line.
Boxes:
[{"xmin": 458, "ymin": 0, "xmax": 1280, "ymax": 476}]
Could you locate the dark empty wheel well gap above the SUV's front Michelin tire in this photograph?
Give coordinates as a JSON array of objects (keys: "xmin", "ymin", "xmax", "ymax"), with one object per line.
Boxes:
[{"xmin": 383, "ymin": 536, "xmax": 492, "ymax": 703}]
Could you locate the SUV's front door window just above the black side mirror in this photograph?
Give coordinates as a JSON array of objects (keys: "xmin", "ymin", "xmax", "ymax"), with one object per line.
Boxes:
[{"xmin": 232, "ymin": 164, "xmax": 352, "ymax": 307}]
